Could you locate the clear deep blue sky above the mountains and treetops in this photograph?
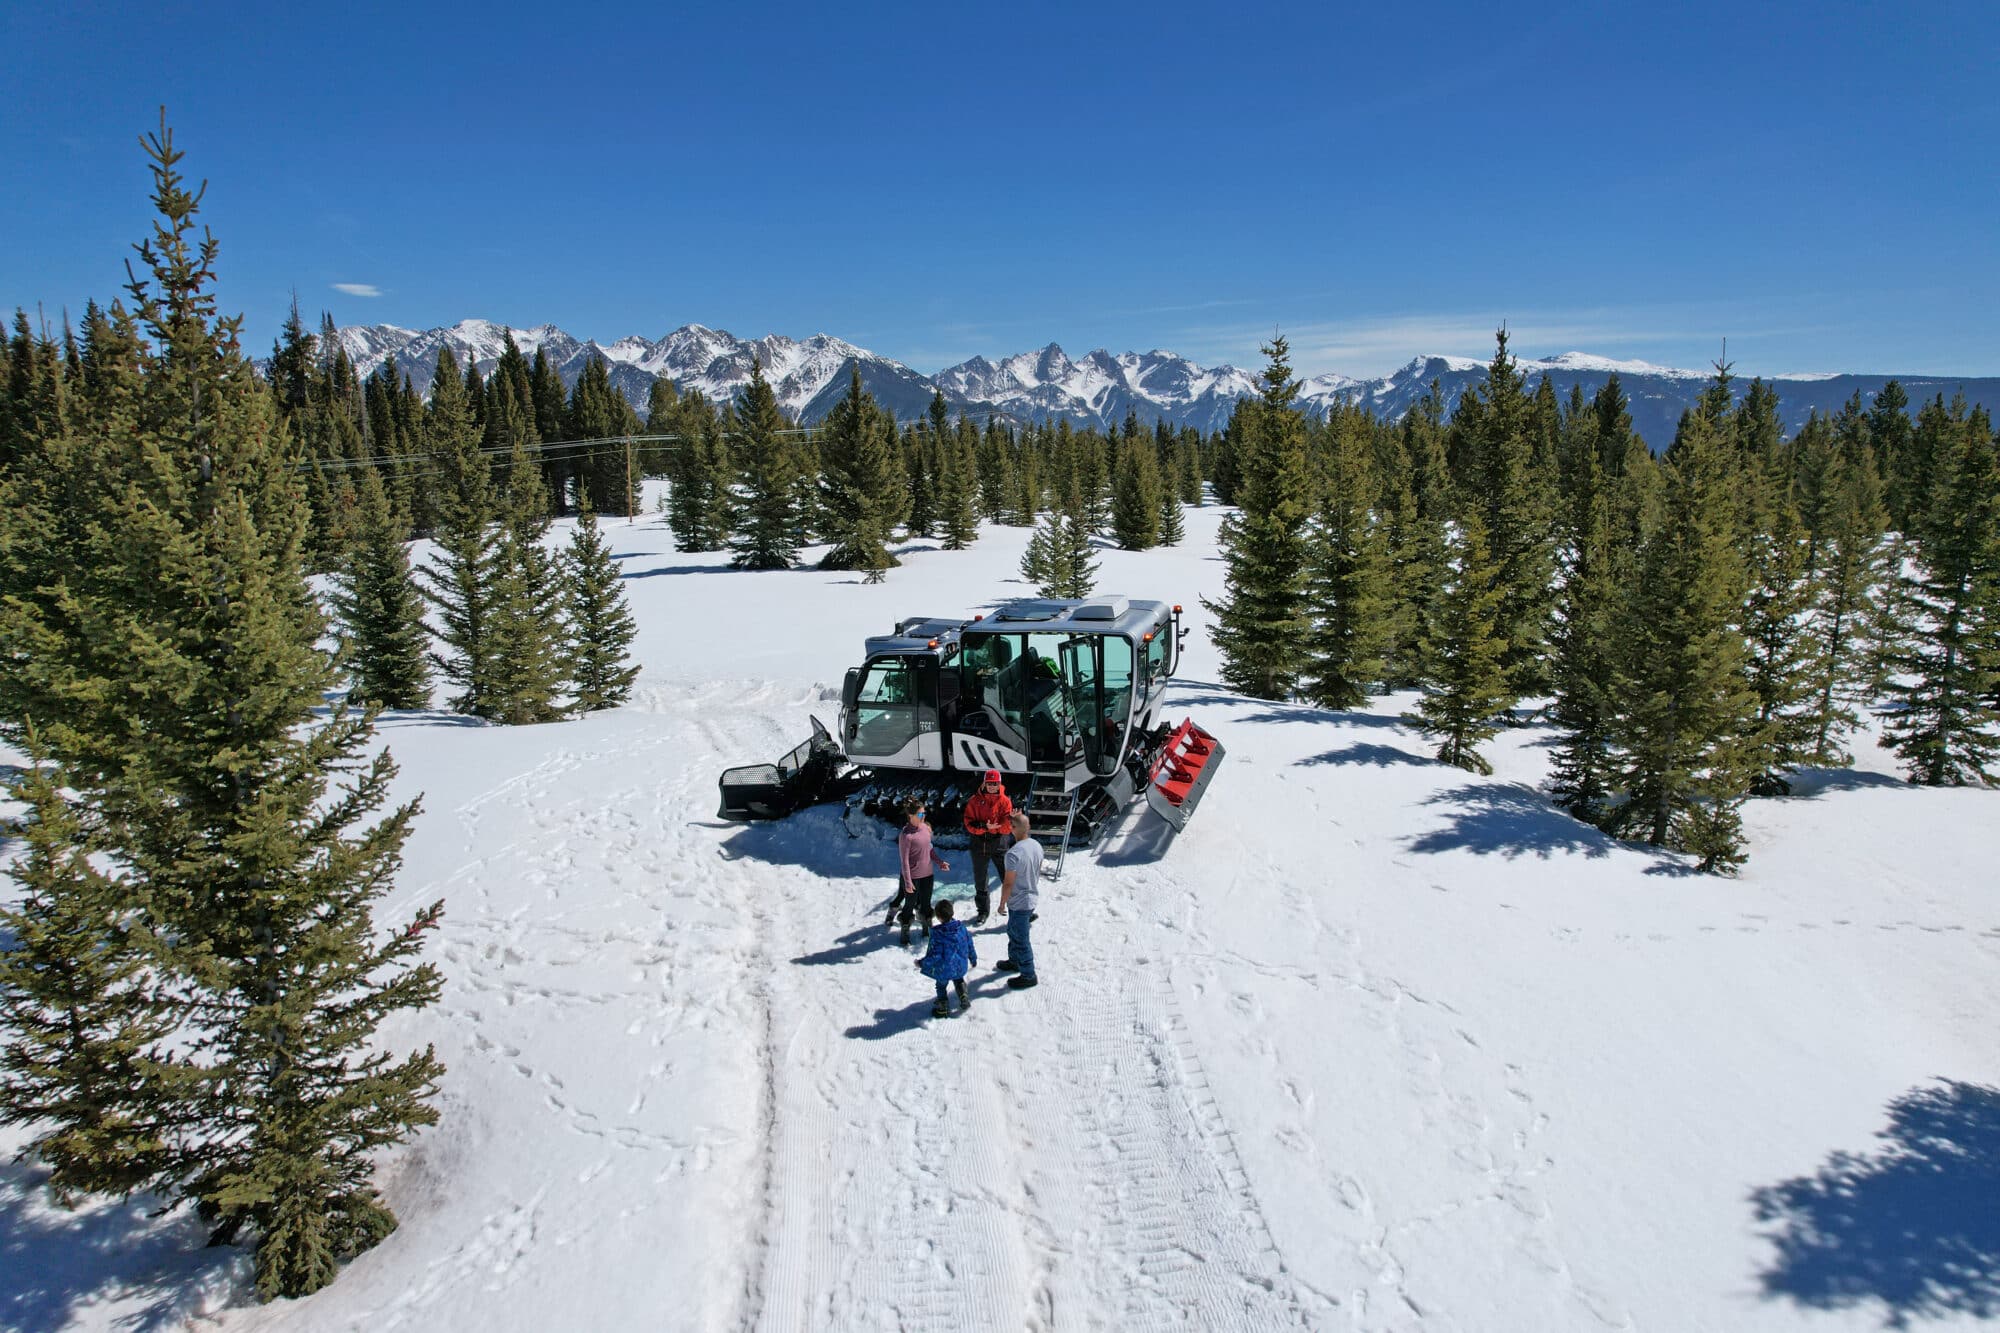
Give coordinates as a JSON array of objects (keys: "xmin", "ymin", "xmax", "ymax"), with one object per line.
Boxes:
[{"xmin": 0, "ymin": 0, "xmax": 2000, "ymax": 374}]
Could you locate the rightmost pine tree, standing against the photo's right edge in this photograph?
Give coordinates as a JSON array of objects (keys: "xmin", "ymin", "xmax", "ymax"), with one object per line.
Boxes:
[{"xmin": 1884, "ymin": 404, "xmax": 2000, "ymax": 787}]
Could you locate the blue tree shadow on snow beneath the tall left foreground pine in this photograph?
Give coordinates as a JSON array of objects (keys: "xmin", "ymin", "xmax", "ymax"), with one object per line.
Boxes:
[{"xmin": 0, "ymin": 1165, "xmax": 240, "ymax": 1333}]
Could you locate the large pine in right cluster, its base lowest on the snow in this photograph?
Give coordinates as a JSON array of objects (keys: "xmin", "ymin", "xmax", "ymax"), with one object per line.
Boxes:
[{"xmin": 1606, "ymin": 412, "xmax": 1756, "ymax": 871}]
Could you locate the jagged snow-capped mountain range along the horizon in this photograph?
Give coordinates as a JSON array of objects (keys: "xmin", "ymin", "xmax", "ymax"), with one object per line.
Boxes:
[{"xmin": 340, "ymin": 320, "xmax": 2000, "ymax": 448}]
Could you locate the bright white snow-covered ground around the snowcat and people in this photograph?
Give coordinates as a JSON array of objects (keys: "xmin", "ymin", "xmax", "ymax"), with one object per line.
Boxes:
[{"xmin": 0, "ymin": 508, "xmax": 2000, "ymax": 1333}]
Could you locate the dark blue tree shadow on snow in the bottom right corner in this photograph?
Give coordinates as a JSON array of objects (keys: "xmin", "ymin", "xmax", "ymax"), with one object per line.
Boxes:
[{"xmin": 1750, "ymin": 1081, "xmax": 2000, "ymax": 1329}]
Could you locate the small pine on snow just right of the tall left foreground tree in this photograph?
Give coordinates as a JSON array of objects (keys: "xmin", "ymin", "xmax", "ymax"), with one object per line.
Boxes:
[{"xmin": 330, "ymin": 470, "xmax": 430, "ymax": 709}]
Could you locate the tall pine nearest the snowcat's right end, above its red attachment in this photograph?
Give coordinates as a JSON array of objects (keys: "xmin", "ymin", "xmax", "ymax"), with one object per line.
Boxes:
[{"xmin": 1202, "ymin": 338, "xmax": 1310, "ymax": 699}]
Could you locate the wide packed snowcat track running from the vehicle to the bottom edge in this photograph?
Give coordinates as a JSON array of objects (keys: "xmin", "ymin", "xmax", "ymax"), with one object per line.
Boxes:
[{"xmin": 688, "ymin": 688, "xmax": 1326, "ymax": 1329}]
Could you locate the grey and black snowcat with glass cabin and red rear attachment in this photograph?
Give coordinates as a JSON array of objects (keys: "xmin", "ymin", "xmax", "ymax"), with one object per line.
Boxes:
[{"xmin": 720, "ymin": 596, "xmax": 1222, "ymax": 873}]
